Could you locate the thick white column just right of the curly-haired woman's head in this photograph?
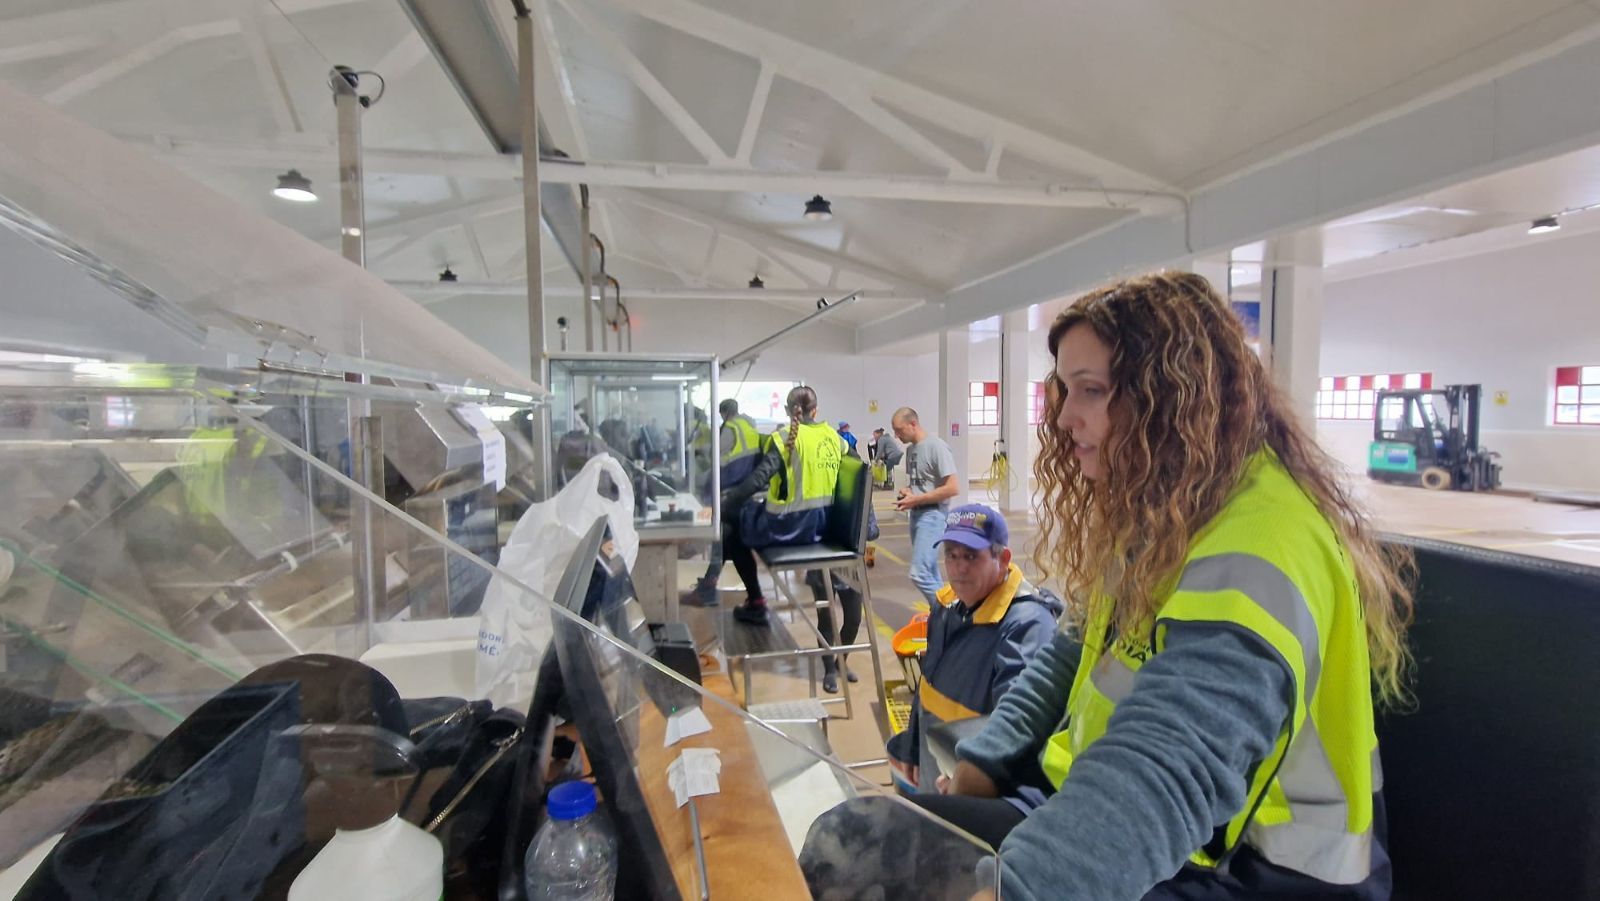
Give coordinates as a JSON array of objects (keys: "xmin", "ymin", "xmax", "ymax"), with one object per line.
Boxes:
[{"xmin": 1261, "ymin": 229, "xmax": 1322, "ymax": 426}]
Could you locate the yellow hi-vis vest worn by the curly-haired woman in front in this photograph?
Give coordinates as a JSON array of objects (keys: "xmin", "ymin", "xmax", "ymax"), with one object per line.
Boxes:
[{"xmin": 1040, "ymin": 450, "xmax": 1382, "ymax": 885}]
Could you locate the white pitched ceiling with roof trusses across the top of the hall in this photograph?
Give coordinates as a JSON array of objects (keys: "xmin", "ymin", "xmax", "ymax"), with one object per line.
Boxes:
[{"xmin": 9, "ymin": 0, "xmax": 1600, "ymax": 358}]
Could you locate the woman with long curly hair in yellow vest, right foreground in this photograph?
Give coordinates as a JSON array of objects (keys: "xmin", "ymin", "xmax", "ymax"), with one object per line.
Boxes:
[{"xmin": 952, "ymin": 272, "xmax": 1411, "ymax": 901}]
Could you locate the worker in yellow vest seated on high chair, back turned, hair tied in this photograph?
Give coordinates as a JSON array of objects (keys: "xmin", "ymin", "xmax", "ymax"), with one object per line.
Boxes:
[{"xmin": 722, "ymin": 386, "xmax": 845, "ymax": 624}]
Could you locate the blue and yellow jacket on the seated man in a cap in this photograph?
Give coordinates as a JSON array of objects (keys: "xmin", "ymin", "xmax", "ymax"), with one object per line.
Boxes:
[{"xmin": 888, "ymin": 563, "xmax": 1064, "ymax": 808}]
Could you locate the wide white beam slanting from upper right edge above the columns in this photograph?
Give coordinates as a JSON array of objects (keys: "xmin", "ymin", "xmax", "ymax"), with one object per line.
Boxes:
[{"xmin": 856, "ymin": 24, "xmax": 1600, "ymax": 350}]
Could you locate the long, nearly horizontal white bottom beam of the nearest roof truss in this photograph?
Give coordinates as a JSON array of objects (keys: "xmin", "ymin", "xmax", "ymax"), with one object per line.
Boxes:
[{"xmin": 130, "ymin": 136, "xmax": 1184, "ymax": 214}]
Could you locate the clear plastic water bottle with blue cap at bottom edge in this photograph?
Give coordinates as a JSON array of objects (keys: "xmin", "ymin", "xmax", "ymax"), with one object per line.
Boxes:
[{"xmin": 523, "ymin": 781, "xmax": 616, "ymax": 901}]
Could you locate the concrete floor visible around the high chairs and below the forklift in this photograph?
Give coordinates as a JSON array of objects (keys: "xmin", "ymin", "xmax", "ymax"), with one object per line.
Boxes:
[{"xmin": 680, "ymin": 482, "xmax": 1600, "ymax": 784}]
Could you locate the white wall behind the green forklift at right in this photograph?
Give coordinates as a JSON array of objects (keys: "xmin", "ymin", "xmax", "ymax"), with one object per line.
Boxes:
[{"xmin": 1317, "ymin": 234, "xmax": 1600, "ymax": 490}]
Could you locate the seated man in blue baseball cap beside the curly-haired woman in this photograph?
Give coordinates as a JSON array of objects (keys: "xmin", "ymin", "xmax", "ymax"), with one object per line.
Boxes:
[{"xmin": 888, "ymin": 504, "xmax": 1064, "ymax": 803}]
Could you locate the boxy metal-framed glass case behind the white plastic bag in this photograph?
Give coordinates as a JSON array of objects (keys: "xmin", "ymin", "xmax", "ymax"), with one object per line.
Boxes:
[{"xmin": 549, "ymin": 354, "xmax": 722, "ymax": 541}]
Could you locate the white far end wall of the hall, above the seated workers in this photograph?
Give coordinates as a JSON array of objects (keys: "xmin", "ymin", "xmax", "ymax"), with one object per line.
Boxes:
[{"xmin": 429, "ymin": 294, "xmax": 940, "ymax": 446}]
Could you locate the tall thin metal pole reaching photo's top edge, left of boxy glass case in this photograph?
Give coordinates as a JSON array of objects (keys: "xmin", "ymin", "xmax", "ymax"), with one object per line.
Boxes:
[{"xmin": 517, "ymin": 3, "xmax": 556, "ymax": 498}]
